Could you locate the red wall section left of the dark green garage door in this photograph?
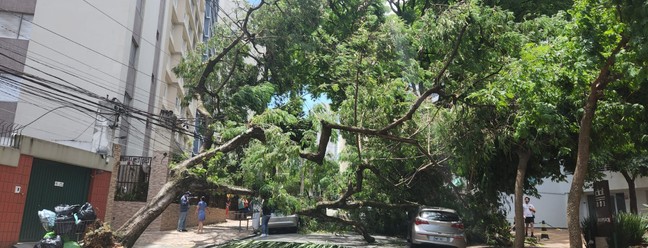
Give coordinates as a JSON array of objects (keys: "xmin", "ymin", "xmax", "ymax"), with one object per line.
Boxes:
[{"xmin": 0, "ymin": 155, "xmax": 33, "ymax": 247}]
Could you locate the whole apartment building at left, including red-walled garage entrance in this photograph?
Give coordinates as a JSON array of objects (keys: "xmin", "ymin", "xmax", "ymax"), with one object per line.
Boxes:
[{"xmin": 0, "ymin": 0, "xmax": 213, "ymax": 244}]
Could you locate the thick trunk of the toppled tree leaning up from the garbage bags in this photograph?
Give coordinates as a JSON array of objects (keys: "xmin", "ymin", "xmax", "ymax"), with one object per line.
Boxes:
[{"xmin": 115, "ymin": 127, "xmax": 265, "ymax": 247}]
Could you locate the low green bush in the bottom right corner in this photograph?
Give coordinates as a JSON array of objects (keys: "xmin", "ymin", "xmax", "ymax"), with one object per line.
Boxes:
[{"xmin": 610, "ymin": 213, "xmax": 648, "ymax": 247}]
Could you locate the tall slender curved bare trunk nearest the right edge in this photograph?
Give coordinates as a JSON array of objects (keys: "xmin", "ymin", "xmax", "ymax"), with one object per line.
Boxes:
[{"xmin": 567, "ymin": 34, "xmax": 629, "ymax": 248}]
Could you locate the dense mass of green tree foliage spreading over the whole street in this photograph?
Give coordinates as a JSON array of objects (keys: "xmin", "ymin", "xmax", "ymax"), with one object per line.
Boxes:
[{"xmin": 114, "ymin": 0, "xmax": 648, "ymax": 247}]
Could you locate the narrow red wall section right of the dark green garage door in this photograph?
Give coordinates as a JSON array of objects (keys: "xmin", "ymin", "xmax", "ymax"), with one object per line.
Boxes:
[{"xmin": 88, "ymin": 170, "xmax": 111, "ymax": 220}]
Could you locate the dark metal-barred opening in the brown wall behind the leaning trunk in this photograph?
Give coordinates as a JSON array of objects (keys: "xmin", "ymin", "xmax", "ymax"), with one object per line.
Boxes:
[{"xmin": 115, "ymin": 156, "xmax": 152, "ymax": 202}]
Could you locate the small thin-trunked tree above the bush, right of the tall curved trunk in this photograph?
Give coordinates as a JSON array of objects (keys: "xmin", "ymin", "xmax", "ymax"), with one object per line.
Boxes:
[{"xmin": 592, "ymin": 69, "xmax": 648, "ymax": 214}]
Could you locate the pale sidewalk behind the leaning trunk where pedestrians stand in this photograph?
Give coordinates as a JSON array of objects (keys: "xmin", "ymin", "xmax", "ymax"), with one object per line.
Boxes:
[{"xmin": 133, "ymin": 220, "xmax": 254, "ymax": 248}]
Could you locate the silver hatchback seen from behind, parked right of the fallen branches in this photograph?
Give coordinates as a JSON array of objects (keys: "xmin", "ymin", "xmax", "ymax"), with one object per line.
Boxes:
[{"xmin": 407, "ymin": 206, "xmax": 467, "ymax": 248}]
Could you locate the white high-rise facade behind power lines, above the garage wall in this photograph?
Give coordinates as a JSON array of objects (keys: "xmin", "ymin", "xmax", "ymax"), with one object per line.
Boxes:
[{"xmin": 0, "ymin": 0, "xmax": 219, "ymax": 234}]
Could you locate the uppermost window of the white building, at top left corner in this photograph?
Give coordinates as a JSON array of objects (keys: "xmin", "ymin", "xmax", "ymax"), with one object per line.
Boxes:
[{"xmin": 0, "ymin": 11, "xmax": 34, "ymax": 40}]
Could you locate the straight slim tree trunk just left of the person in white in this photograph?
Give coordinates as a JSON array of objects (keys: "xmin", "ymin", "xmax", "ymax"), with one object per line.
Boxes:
[{"xmin": 514, "ymin": 148, "xmax": 531, "ymax": 248}]
